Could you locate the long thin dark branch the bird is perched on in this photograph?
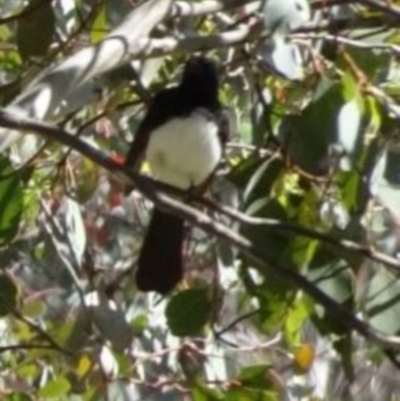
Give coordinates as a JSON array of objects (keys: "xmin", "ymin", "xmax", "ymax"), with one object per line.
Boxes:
[{"xmin": 0, "ymin": 110, "xmax": 400, "ymax": 350}]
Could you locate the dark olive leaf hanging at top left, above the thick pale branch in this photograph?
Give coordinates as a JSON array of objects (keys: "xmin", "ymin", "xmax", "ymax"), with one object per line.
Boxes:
[{"xmin": 17, "ymin": 0, "xmax": 55, "ymax": 60}]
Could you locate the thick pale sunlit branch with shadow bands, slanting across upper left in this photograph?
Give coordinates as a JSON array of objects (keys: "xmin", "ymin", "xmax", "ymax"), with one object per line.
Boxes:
[{"xmin": 0, "ymin": 0, "xmax": 172, "ymax": 150}]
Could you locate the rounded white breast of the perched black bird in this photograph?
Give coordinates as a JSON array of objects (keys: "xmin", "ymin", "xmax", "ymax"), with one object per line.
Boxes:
[{"xmin": 146, "ymin": 110, "xmax": 222, "ymax": 189}]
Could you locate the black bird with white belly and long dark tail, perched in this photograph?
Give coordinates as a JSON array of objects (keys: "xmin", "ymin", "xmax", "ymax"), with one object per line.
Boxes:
[{"xmin": 126, "ymin": 56, "xmax": 229, "ymax": 295}]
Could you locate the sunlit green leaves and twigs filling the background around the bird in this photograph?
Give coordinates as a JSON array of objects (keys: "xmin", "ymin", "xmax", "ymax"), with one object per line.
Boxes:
[{"xmin": 0, "ymin": 0, "xmax": 400, "ymax": 401}]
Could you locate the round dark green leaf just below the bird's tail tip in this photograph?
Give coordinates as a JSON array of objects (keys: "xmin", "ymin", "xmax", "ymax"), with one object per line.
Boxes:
[{"xmin": 165, "ymin": 289, "xmax": 212, "ymax": 337}]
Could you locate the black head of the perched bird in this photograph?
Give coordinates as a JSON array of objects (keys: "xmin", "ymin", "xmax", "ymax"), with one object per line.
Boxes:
[{"xmin": 180, "ymin": 57, "xmax": 218, "ymax": 106}]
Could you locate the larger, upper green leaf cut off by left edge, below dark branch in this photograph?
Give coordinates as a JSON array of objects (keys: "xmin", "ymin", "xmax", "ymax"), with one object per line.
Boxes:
[{"xmin": 0, "ymin": 156, "xmax": 23, "ymax": 244}]
